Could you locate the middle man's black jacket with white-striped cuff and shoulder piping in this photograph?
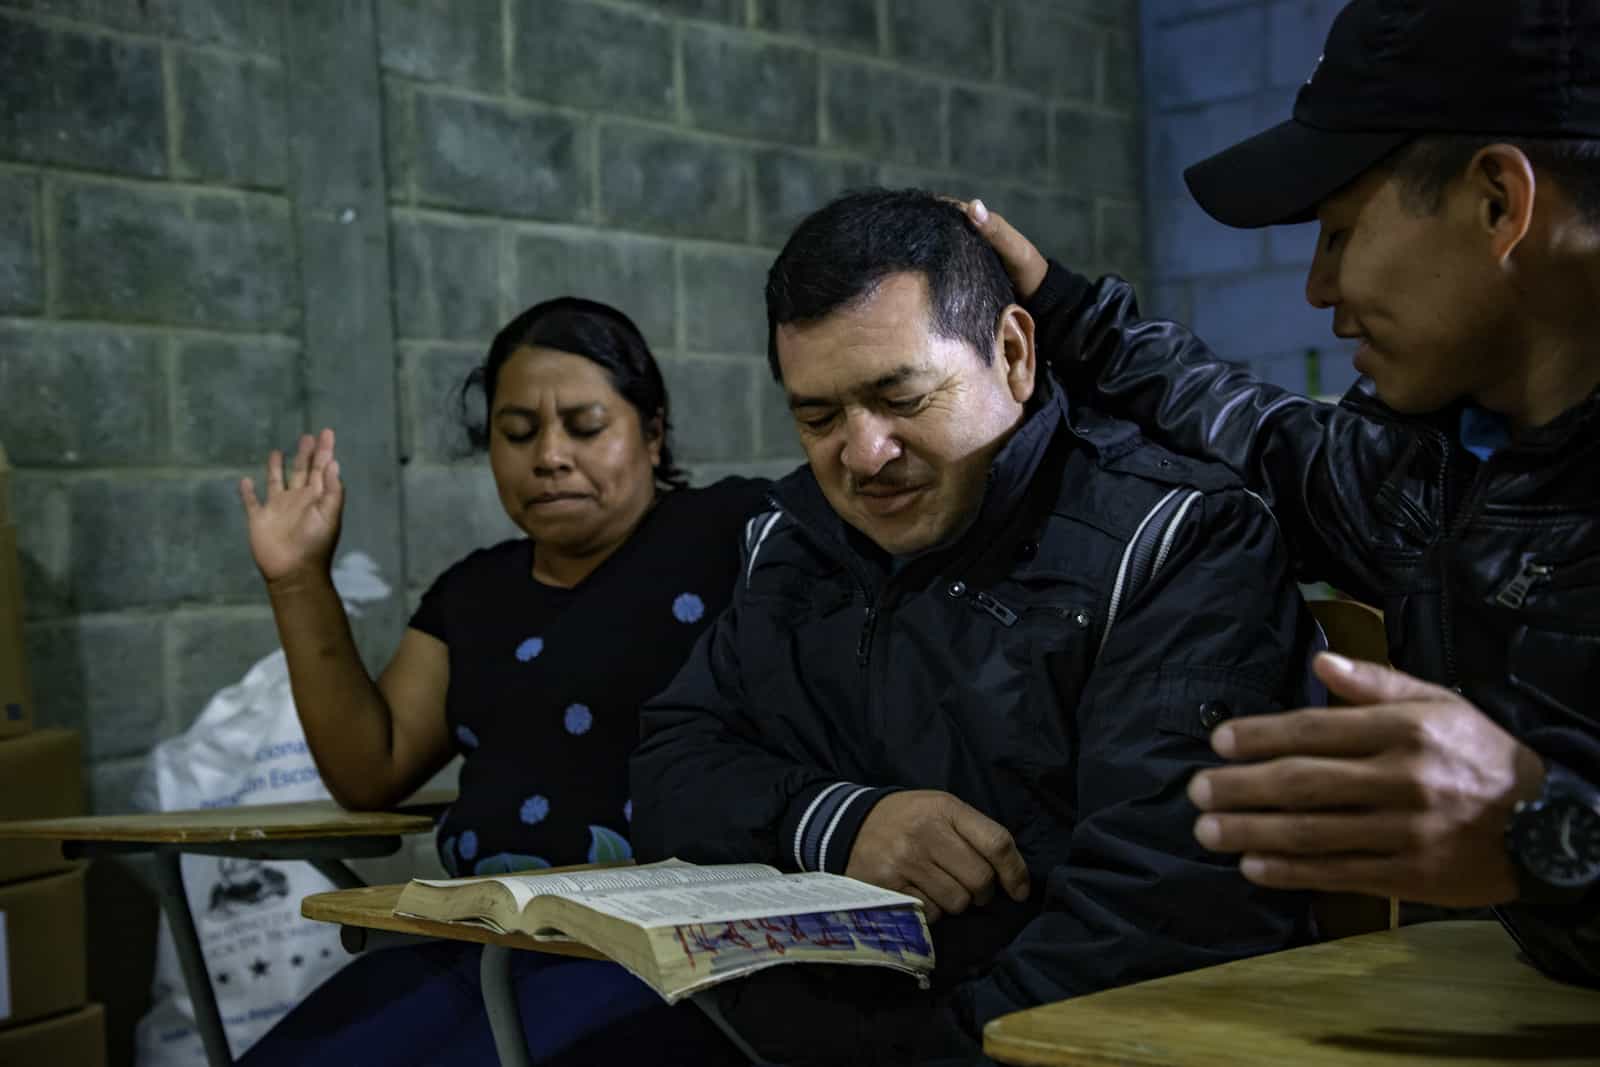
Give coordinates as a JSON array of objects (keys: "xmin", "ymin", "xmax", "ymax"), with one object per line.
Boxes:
[{"xmin": 632, "ymin": 376, "xmax": 1317, "ymax": 1062}]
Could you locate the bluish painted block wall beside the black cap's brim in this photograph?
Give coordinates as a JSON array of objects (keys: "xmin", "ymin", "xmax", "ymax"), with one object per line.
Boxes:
[{"xmin": 1141, "ymin": 0, "xmax": 1355, "ymax": 394}]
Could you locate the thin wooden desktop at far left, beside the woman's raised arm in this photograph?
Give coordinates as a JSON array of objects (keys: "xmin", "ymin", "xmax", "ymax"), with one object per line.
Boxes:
[{"xmin": 0, "ymin": 797, "xmax": 437, "ymax": 845}]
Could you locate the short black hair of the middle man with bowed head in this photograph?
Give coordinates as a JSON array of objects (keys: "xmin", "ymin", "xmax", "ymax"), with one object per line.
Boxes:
[{"xmin": 766, "ymin": 189, "xmax": 1016, "ymax": 382}]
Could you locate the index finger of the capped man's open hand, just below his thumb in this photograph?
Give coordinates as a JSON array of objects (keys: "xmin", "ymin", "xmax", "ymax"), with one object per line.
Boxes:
[{"xmin": 1211, "ymin": 707, "xmax": 1416, "ymax": 760}]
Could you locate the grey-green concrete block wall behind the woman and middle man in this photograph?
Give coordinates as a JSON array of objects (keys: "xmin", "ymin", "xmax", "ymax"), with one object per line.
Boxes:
[{"xmin": 0, "ymin": 0, "xmax": 1146, "ymax": 811}]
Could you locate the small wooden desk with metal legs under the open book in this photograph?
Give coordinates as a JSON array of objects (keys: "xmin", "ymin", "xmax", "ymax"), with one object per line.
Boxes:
[{"xmin": 301, "ymin": 861, "xmax": 762, "ymax": 1067}]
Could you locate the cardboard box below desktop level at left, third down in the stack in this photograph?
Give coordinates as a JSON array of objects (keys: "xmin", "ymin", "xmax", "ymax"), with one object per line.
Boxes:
[{"xmin": 0, "ymin": 867, "xmax": 90, "ymax": 1027}]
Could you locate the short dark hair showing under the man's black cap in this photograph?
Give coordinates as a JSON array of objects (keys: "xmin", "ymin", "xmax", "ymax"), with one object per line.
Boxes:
[{"xmin": 1389, "ymin": 133, "xmax": 1600, "ymax": 226}]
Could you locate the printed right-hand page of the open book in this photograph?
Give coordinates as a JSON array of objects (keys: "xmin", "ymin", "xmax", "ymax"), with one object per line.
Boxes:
[{"xmin": 556, "ymin": 872, "xmax": 917, "ymax": 928}]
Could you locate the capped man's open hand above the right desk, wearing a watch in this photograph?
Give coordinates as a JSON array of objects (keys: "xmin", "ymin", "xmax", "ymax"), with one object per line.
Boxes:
[{"xmin": 1189, "ymin": 653, "xmax": 1544, "ymax": 907}]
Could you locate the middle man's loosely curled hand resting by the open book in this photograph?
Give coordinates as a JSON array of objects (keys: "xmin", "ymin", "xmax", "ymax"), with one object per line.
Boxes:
[{"xmin": 845, "ymin": 789, "xmax": 1029, "ymax": 923}]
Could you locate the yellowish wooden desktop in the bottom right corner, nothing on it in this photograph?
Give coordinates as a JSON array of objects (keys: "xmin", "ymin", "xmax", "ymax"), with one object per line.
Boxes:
[{"xmin": 984, "ymin": 921, "xmax": 1600, "ymax": 1067}]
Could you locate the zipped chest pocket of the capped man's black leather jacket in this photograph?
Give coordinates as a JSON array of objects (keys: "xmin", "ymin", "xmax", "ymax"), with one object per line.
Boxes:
[{"xmin": 1494, "ymin": 555, "xmax": 1600, "ymax": 721}]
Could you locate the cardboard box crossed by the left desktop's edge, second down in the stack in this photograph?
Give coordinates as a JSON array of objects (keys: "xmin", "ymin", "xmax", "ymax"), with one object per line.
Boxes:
[{"xmin": 0, "ymin": 729, "xmax": 86, "ymax": 883}]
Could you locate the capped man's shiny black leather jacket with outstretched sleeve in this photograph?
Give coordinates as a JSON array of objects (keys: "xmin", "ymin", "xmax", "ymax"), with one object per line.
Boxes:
[{"xmin": 1030, "ymin": 262, "xmax": 1600, "ymax": 984}]
